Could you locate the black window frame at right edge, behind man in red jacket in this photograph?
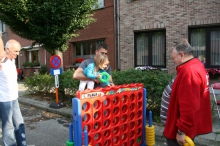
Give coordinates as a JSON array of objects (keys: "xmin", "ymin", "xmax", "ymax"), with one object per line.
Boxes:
[{"xmin": 188, "ymin": 25, "xmax": 220, "ymax": 68}]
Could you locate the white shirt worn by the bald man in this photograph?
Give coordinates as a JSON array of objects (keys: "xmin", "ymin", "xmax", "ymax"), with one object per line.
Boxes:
[{"xmin": 0, "ymin": 59, "xmax": 18, "ymax": 102}]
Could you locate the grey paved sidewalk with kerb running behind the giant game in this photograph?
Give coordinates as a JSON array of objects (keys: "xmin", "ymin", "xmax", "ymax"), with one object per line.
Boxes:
[{"xmin": 18, "ymin": 82, "xmax": 220, "ymax": 146}]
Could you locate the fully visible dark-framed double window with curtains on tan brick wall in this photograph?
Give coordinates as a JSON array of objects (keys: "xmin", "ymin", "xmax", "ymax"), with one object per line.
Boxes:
[{"xmin": 134, "ymin": 31, "xmax": 166, "ymax": 67}]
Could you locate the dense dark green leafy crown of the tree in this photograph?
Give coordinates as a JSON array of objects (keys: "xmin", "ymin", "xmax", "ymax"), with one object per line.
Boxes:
[{"xmin": 0, "ymin": 0, "xmax": 97, "ymax": 55}]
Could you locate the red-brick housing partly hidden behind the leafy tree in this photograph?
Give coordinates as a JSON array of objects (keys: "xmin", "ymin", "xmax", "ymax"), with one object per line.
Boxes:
[{"xmin": 0, "ymin": 0, "xmax": 116, "ymax": 76}]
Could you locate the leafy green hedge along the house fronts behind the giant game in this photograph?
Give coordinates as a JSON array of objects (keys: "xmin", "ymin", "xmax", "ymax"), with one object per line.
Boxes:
[{"xmin": 24, "ymin": 69, "xmax": 173, "ymax": 121}]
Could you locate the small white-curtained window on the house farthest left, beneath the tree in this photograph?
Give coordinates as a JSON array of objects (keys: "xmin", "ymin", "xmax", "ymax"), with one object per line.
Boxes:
[{"xmin": 26, "ymin": 50, "xmax": 40, "ymax": 63}]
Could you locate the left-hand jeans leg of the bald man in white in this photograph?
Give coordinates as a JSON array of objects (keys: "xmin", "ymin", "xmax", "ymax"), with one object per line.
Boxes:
[{"xmin": 0, "ymin": 102, "xmax": 17, "ymax": 146}]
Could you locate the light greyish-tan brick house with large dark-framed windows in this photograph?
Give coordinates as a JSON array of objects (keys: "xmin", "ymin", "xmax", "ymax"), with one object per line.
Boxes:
[{"xmin": 119, "ymin": 0, "xmax": 220, "ymax": 72}]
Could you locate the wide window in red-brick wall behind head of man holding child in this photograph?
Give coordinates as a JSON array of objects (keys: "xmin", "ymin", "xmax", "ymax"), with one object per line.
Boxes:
[{"xmin": 74, "ymin": 40, "xmax": 104, "ymax": 58}]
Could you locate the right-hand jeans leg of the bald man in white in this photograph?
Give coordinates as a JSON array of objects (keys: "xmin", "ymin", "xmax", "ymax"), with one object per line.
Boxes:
[{"xmin": 12, "ymin": 99, "xmax": 27, "ymax": 146}]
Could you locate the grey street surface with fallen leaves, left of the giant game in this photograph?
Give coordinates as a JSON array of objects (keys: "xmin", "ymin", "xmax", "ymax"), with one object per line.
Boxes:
[{"xmin": 0, "ymin": 105, "xmax": 70, "ymax": 146}]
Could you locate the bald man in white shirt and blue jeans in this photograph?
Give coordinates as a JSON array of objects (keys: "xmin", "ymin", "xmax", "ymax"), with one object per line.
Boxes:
[{"xmin": 0, "ymin": 40, "xmax": 27, "ymax": 146}]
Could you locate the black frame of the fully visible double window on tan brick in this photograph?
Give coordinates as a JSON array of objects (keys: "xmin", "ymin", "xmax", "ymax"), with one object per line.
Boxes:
[{"xmin": 134, "ymin": 29, "xmax": 166, "ymax": 68}]
